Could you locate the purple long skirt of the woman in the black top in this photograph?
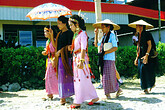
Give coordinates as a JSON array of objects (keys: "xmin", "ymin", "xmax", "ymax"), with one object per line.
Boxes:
[{"xmin": 58, "ymin": 57, "xmax": 74, "ymax": 98}]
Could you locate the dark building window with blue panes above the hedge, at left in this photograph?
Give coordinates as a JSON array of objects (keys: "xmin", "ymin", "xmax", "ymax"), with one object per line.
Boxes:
[{"xmin": 3, "ymin": 24, "xmax": 47, "ymax": 47}]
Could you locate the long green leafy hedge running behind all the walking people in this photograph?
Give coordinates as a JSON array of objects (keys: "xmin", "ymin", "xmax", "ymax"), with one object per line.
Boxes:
[{"xmin": 0, "ymin": 42, "xmax": 165, "ymax": 88}]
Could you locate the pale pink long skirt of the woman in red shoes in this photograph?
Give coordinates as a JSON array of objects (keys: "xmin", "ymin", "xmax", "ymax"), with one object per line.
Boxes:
[{"xmin": 73, "ymin": 54, "xmax": 98, "ymax": 104}]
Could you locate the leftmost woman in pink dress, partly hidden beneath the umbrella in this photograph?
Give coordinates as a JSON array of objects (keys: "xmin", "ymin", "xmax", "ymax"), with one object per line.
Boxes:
[{"xmin": 42, "ymin": 26, "xmax": 58, "ymax": 99}]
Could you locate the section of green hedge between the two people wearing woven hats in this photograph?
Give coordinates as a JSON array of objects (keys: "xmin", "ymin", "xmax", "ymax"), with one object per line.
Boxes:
[{"xmin": 116, "ymin": 46, "xmax": 138, "ymax": 77}]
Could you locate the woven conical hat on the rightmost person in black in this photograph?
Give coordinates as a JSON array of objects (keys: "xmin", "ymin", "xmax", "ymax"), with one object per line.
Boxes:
[{"xmin": 128, "ymin": 20, "xmax": 154, "ymax": 29}]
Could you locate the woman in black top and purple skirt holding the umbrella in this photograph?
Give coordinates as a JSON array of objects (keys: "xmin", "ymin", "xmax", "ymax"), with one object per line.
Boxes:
[{"xmin": 54, "ymin": 16, "xmax": 74, "ymax": 105}]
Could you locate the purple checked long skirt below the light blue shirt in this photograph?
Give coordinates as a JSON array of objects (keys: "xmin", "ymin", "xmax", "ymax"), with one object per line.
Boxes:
[{"xmin": 102, "ymin": 60, "xmax": 119, "ymax": 95}]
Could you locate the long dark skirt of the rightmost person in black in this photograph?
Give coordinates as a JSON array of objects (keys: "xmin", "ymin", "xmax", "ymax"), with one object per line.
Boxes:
[{"xmin": 138, "ymin": 59, "xmax": 155, "ymax": 90}]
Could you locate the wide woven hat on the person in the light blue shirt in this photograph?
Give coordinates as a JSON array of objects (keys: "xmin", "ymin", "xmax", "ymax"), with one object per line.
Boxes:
[{"xmin": 93, "ymin": 19, "xmax": 120, "ymax": 30}]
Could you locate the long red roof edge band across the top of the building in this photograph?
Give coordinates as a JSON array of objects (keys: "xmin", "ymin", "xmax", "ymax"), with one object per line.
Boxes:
[{"xmin": 0, "ymin": 0, "xmax": 165, "ymax": 21}]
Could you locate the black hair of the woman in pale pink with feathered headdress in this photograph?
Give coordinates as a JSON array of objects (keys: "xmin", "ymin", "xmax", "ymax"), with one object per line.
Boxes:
[{"xmin": 70, "ymin": 15, "xmax": 86, "ymax": 30}]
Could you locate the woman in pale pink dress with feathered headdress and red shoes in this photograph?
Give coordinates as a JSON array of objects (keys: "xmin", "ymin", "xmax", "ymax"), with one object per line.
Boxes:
[{"xmin": 69, "ymin": 15, "xmax": 99, "ymax": 108}]
